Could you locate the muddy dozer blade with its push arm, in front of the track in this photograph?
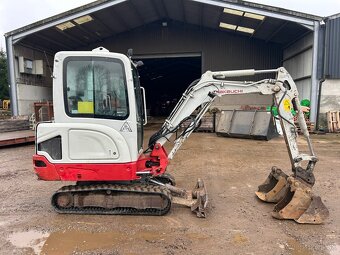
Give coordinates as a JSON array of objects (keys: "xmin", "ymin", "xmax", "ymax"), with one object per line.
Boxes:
[{"xmin": 165, "ymin": 179, "xmax": 208, "ymax": 218}]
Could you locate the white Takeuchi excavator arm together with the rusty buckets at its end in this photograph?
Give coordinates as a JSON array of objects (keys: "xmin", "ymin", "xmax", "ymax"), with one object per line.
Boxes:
[{"xmin": 149, "ymin": 67, "xmax": 328, "ymax": 224}]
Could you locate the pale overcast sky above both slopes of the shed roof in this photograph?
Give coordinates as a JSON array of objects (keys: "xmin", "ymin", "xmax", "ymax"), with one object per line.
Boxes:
[{"xmin": 0, "ymin": 0, "xmax": 340, "ymax": 48}]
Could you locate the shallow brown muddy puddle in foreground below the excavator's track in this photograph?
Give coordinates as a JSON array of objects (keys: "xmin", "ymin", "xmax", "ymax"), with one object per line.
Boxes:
[{"xmin": 8, "ymin": 230, "xmax": 208, "ymax": 255}]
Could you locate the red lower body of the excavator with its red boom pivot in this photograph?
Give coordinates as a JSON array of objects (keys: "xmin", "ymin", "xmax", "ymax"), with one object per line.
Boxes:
[{"xmin": 33, "ymin": 144, "xmax": 168, "ymax": 181}]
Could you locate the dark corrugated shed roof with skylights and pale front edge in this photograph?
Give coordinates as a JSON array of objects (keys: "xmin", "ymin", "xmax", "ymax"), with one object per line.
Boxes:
[{"xmin": 5, "ymin": 0, "xmax": 321, "ymax": 53}]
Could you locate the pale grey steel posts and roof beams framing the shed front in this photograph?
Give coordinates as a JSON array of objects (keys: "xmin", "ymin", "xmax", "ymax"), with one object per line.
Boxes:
[{"xmin": 5, "ymin": 0, "xmax": 321, "ymax": 121}]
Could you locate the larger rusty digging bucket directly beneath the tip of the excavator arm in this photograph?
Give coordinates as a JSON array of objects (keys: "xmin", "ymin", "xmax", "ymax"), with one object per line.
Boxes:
[{"xmin": 272, "ymin": 177, "xmax": 329, "ymax": 224}]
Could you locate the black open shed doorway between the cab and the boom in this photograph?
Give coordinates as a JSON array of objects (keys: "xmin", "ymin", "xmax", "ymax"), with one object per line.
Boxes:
[{"xmin": 136, "ymin": 55, "xmax": 202, "ymax": 117}]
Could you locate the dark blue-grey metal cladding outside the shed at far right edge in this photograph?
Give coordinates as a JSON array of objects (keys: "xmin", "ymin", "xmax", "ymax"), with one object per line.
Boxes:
[{"xmin": 325, "ymin": 17, "xmax": 340, "ymax": 79}]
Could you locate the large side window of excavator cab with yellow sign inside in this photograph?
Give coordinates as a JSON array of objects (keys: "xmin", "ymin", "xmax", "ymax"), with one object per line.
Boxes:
[{"xmin": 64, "ymin": 57, "xmax": 129, "ymax": 119}]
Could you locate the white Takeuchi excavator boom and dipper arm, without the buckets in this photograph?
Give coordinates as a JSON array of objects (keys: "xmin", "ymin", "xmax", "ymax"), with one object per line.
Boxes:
[{"xmin": 149, "ymin": 67, "xmax": 317, "ymax": 163}]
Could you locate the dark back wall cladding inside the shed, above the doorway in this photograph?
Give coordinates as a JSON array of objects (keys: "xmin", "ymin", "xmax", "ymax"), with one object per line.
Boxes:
[{"xmin": 91, "ymin": 21, "xmax": 282, "ymax": 72}]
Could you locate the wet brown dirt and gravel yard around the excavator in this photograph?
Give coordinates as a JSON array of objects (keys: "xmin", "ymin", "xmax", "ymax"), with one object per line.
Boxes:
[{"xmin": 0, "ymin": 127, "xmax": 340, "ymax": 255}]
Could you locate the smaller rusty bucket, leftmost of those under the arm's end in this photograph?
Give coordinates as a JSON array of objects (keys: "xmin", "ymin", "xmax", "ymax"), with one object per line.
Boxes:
[{"xmin": 255, "ymin": 166, "xmax": 289, "ymax": 203}]
